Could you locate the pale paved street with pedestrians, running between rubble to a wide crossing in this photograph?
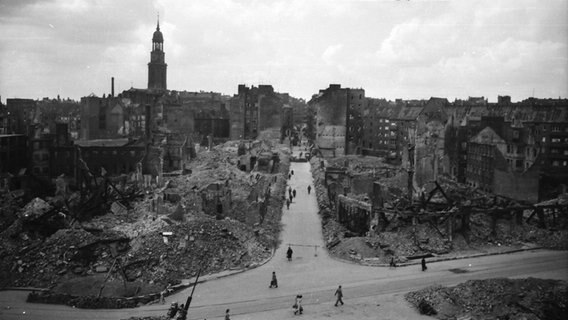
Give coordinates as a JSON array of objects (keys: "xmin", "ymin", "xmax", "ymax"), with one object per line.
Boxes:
[{"xmin": 0, "ymin": 158, "xmax": 568, "ymax": 319}]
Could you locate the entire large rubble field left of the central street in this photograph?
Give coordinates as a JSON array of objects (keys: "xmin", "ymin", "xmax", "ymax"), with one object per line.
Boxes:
[{"xmin": 0, "ymin": 142, "xmax": 290, "ymax": 300}]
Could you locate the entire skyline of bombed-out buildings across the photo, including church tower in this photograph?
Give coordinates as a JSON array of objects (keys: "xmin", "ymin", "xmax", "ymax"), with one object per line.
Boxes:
[{"xmin": 0, "ymin": 20, "xmax": 568, "ymax": 202}]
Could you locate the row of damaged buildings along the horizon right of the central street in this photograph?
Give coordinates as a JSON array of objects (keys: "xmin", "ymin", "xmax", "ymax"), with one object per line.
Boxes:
[{"xmin": 308, "ymin": 84, "xmax": 568, "ymax": 202}]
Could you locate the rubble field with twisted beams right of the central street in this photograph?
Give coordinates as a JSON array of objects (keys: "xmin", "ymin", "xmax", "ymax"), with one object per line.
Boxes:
[{"xmin": 311, "ymin": 156, "xmax": 568, "ymax": 263}]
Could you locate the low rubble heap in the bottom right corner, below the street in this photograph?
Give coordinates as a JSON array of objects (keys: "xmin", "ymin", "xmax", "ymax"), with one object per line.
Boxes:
[{"xmin": 405, "ymin": 278, "xmax": 568, "ymax": 320}]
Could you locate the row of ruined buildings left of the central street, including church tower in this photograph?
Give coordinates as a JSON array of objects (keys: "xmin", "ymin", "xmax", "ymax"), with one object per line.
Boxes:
[{"xmin": 0, "ymin": 23, "xmax": 305, "ymax": 198}]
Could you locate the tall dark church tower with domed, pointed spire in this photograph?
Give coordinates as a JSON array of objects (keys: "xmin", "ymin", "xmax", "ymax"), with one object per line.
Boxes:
[{"xmin": 148, "ymin": 19, "xmax": 168, "ymax": 90}]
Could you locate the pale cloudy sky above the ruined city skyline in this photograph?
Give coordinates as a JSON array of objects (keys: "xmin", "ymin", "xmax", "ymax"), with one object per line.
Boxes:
[{"xmin": 0, "ymin": 0, "xmax": 568, "ymax": 102}]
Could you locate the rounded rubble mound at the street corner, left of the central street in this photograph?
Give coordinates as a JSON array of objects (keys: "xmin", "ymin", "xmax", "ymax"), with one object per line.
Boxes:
[{"xmin": 121, "ymin": 215, "xmax": 271, "ymax": 283}]
